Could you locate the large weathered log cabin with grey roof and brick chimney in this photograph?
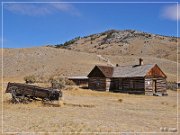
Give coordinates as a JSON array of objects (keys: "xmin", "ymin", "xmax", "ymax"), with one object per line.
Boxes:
[{"xmin": 88, "ymin": 59, "xmax": 167, "ymax": 95}]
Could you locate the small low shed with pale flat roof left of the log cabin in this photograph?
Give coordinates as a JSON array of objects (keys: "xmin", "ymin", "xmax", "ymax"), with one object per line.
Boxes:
[{"xmin": 68, "ymin": 76, "xmax": 88, "ymax": 86}]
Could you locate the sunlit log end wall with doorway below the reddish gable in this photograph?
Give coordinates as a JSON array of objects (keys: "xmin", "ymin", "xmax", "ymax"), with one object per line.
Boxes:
[{"xmin": 145, "ymin": 77, "xmax": 167, "ymax": 95}]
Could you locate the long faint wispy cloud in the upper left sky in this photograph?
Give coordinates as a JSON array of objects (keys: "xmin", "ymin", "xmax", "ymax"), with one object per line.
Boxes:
[{"xmin": 4, "ymin": 3, "xmax": 80, "ymax": 16}]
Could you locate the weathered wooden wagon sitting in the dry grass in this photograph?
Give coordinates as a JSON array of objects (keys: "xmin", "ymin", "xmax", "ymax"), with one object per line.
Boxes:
[{"xmin": 5, "ymin": 82, "xmax": 62, "ymax": 103}]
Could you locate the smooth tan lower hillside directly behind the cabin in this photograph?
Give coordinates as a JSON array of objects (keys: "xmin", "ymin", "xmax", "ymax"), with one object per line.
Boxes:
[{"xmin": 0, "ymin": 47, "xmax": 177, "ymax": 81}]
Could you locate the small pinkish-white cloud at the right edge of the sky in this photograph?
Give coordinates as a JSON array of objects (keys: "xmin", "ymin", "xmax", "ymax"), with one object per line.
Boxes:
[{"xmin": 162, "ymin": 4, "xmax": 180, "ymax": 20}]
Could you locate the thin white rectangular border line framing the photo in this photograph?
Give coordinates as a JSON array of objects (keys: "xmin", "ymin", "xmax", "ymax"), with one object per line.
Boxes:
[{"xmin": 1, "ymin": 1, "xmax": 179, "ymax": 134}]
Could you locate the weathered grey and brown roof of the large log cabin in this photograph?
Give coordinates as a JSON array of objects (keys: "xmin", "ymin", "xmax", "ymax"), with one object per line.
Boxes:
[{"xmin": 88, "ymin": 64, "xmax": 166, "ymax": 78}]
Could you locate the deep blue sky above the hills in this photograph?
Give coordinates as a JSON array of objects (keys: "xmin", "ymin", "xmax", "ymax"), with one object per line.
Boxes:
[{"xmin": 1, "ymin": 0, "xmax": 180, "ymax": 48}]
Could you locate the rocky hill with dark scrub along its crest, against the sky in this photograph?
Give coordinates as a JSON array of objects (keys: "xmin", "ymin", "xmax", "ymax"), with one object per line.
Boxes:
[{"xmin": 52, "ymin": 30, "xmax": 180, "ymax": 61}]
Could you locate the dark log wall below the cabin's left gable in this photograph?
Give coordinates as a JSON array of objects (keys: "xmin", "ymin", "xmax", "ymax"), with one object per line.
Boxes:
[{"xmin": 88, "ymin": 77, "xmax": 107, "ymax": 91}]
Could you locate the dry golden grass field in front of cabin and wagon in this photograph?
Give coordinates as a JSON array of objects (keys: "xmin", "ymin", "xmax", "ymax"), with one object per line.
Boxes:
[{"xmin": 1, "ymin": 82, "xmax": 180, "ymax": 134}]
